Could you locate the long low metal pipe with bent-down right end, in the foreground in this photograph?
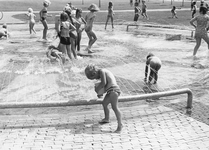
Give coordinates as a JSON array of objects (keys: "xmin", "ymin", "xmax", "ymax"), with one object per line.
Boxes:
[{"xmin": 0, "ymin": 88, "xmax": 193, "ymax": 113}]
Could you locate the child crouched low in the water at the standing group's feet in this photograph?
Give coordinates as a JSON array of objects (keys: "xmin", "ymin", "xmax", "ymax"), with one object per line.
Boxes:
[{"xmin": 46, "ymin": 45, "xmax": 65, "ymax": 64}]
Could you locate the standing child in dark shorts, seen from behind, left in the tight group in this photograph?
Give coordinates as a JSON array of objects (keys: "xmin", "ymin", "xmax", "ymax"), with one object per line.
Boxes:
[{"xmin": 59, "ymin": 12, "xmax": 77, "ymax": 59}]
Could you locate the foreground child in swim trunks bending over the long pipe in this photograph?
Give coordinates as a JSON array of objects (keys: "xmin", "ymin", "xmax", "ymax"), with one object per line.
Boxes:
[{"xmin": 85, "ymin": 65, "xmax": 122, "ymax": 133}]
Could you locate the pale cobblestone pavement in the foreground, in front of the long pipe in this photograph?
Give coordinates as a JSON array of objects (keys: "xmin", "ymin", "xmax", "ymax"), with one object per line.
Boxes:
[{"xmin": 0, "ymin": 105, "xmax": 209, "ymax": 150}]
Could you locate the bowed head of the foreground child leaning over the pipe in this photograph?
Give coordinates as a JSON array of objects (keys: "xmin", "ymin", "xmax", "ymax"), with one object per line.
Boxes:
[{"xmin": 85, "ymin": 64, "xmax": 98, "ymax": 80}]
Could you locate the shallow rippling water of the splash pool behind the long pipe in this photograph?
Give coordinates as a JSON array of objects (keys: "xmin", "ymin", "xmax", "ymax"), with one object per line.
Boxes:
[{"xmin": 0, "ymin": 25, "xmax": 209, "ymax": 102}]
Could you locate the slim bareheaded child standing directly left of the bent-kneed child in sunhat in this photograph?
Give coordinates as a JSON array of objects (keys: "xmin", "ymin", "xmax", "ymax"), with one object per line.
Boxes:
[{"xmin": 75, "ymin": 9, "xmax": 86, "ymax": 51}]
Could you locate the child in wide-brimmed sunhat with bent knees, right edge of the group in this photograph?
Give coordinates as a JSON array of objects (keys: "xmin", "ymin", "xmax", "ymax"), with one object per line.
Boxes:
[{"xmin": 85, "ymin": 4, "xmax": 99, "ymax": 53}]
